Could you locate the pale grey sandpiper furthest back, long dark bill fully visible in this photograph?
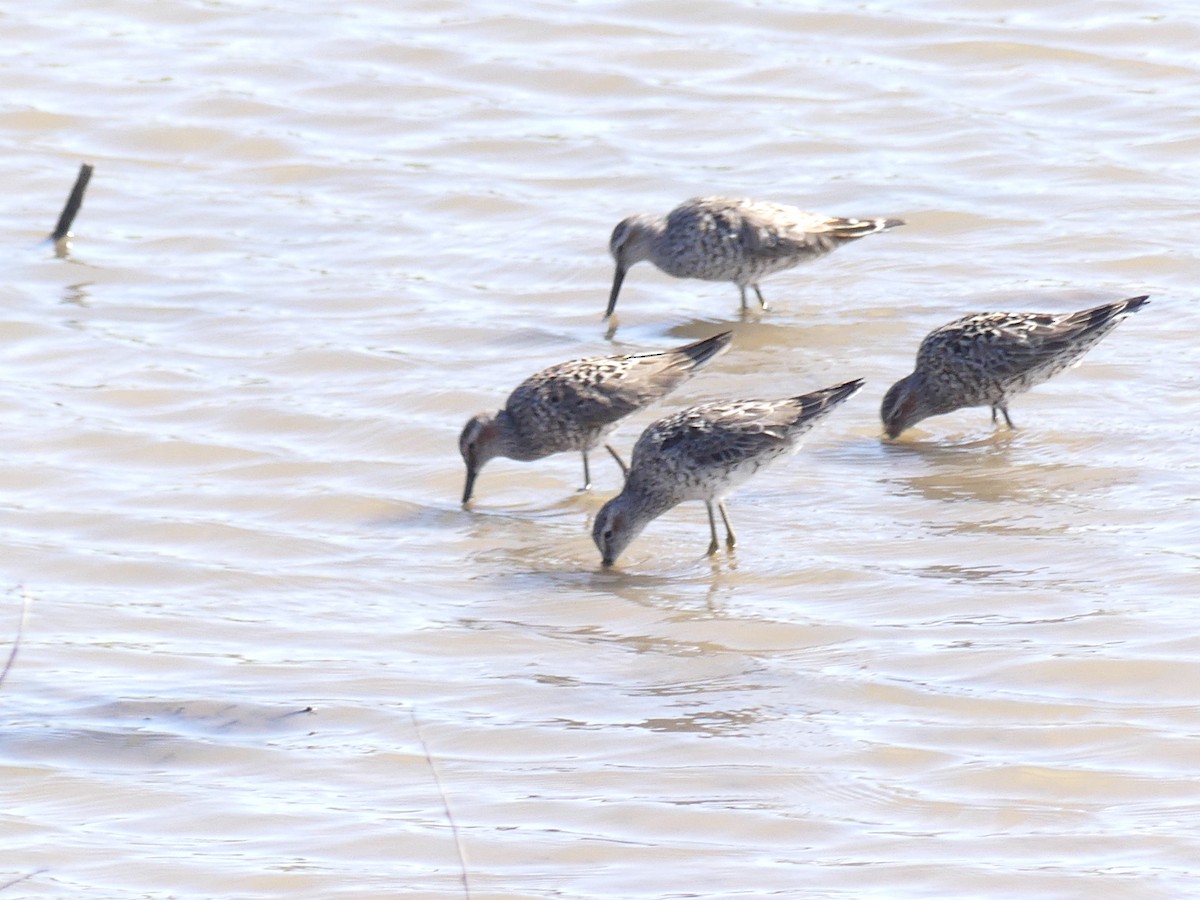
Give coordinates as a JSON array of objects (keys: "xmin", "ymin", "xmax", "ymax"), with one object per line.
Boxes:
[{"xmin": 604, "ymin": 197, "xmax": 904, "ymax": 318}]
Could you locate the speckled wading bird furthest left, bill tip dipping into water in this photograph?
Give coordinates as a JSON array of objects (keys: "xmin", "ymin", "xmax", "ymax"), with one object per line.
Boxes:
[{"xmin": 458, "ymin": 331, "xmax": 732, "ymax": 504}]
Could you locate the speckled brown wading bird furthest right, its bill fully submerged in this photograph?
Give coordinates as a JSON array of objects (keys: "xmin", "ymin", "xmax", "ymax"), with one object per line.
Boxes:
[{"xmin": 880, "ymin": 296, "xmax": 1148, "ymax": 438}]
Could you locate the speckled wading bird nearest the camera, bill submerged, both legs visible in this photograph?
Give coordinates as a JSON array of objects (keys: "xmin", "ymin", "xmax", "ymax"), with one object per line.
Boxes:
[{"xmin": 592, "ymin": 380, "xmax": 863, "ymax": 566}]
